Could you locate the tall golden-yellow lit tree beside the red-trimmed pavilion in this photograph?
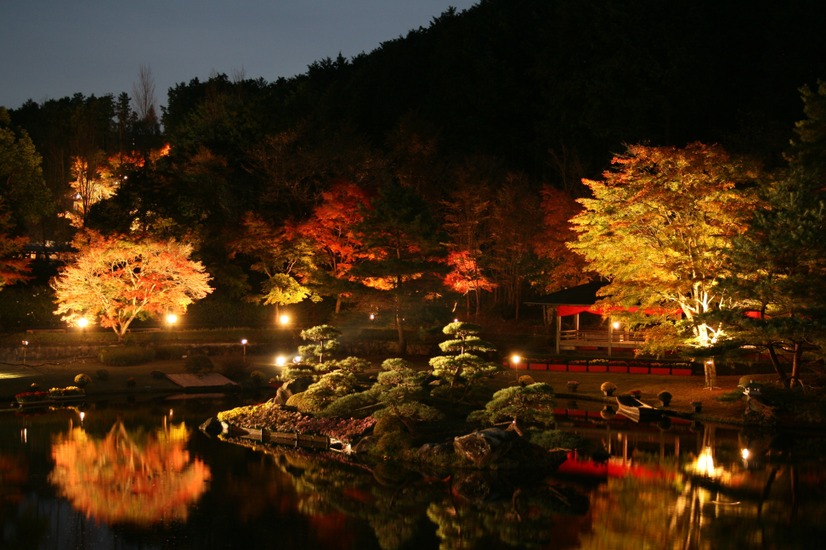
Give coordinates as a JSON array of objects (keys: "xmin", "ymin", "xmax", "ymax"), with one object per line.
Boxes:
[{"xmin": 570, "ymin": 143, "xmax": 757, "ymax": 370}]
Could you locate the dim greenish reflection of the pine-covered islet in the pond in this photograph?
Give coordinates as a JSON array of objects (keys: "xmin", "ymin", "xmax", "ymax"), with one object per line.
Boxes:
[{"xmin": 229, "ymin": 442, "xmax": 589, "ymax": 549}]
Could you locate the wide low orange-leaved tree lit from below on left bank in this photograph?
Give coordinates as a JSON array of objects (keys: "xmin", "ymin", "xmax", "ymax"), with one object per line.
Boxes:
[{"xmin": 51, "ymin": 232, "xmax": 212, "ymax": 341}]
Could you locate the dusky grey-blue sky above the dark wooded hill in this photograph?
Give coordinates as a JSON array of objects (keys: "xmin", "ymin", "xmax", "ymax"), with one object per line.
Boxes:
[{"xmin": 0, "ymin": 0, "xmax": 477, "ymax": 109}]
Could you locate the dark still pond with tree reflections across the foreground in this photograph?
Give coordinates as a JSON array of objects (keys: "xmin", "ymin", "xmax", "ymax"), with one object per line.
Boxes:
[{"xmin": 0, "ymin": 396, "xmax": 826, "ymax": 550}]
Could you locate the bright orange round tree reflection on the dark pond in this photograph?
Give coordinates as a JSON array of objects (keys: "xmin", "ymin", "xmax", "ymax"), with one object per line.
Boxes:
[{"xmin": 49, "ymin": 422, "xmax": 210, "ymax": 526}]
